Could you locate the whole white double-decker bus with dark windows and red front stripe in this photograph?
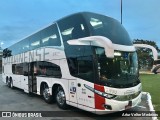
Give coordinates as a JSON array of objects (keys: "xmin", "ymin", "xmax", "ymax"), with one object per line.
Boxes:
[{"xmin": 2, "ymin": 12, "xmax": 142, "ymax": 114}]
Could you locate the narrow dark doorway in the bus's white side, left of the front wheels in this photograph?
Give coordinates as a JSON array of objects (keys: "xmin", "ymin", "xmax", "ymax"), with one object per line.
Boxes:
[{"xmin": 28, "ymin": 62, "xmax": 37, "ymax": 93}]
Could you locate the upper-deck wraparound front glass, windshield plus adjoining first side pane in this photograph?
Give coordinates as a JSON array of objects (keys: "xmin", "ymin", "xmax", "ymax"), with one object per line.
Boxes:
[{"xmin": 58, "ymin": 12, "xmax": 132, "ymax": 45}]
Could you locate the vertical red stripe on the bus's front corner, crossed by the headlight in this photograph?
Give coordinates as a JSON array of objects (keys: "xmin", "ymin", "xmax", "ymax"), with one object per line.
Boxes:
[{"xmin": 94, "ymin": 84, "xmax": 105, "ymax": 110}]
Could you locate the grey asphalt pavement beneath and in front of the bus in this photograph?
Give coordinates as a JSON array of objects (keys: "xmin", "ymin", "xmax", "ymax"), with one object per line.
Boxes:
[{"xmin": 0, "ymin": 75, "xmax": 152, "ymax": 120}]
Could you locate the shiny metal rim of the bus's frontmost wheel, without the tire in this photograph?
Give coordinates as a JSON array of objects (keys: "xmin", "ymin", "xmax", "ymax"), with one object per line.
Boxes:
[{"xmin": 56, "ymin": 90, "xmax": 66, "ymax": 105}]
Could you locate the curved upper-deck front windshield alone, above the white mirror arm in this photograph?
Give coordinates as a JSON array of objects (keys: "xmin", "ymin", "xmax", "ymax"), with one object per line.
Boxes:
[{"xmin": 84, "ymin": 13, "xmax": 132, "ymax": 45}]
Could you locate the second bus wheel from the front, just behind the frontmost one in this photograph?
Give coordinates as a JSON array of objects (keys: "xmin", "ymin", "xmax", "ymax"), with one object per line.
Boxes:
[{"xmin": 43, "ymin": 86, "xmax": 53, "ymax": 103}]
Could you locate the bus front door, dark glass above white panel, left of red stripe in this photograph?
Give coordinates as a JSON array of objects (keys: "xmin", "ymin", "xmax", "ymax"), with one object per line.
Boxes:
[{"xmin": 76, "ymin": 55, "xmax": 95, "ymax": 111}]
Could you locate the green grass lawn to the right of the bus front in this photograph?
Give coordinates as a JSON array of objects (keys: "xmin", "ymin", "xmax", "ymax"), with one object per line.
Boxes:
[{"xmin": 140, "ymin": 74, "xmax": 160, "ymax": 112}]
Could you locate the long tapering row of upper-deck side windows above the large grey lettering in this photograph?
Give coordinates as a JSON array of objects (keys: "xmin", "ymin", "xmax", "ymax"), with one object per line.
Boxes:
[{"xmin": 3, "ymin": 24, "xmax": 61, "ymax": 58}]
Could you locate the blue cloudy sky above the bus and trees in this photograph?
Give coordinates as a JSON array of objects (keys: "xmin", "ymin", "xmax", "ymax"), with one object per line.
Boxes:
[{"xmin": 0, "ymin": 0, "xmax": 160, "ymax": 48}]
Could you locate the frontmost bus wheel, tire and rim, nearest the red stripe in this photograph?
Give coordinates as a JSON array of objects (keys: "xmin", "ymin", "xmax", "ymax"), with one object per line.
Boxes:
[{"xmin": 56, "ymin": 86, "xmax": 67, "ymax": 109}]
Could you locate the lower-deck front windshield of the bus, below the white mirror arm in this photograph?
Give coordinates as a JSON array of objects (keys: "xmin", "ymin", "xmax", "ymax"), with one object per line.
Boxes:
[{"xmin": 95, "ymin": 47, "xmax": 139, "ymax": 88}]
